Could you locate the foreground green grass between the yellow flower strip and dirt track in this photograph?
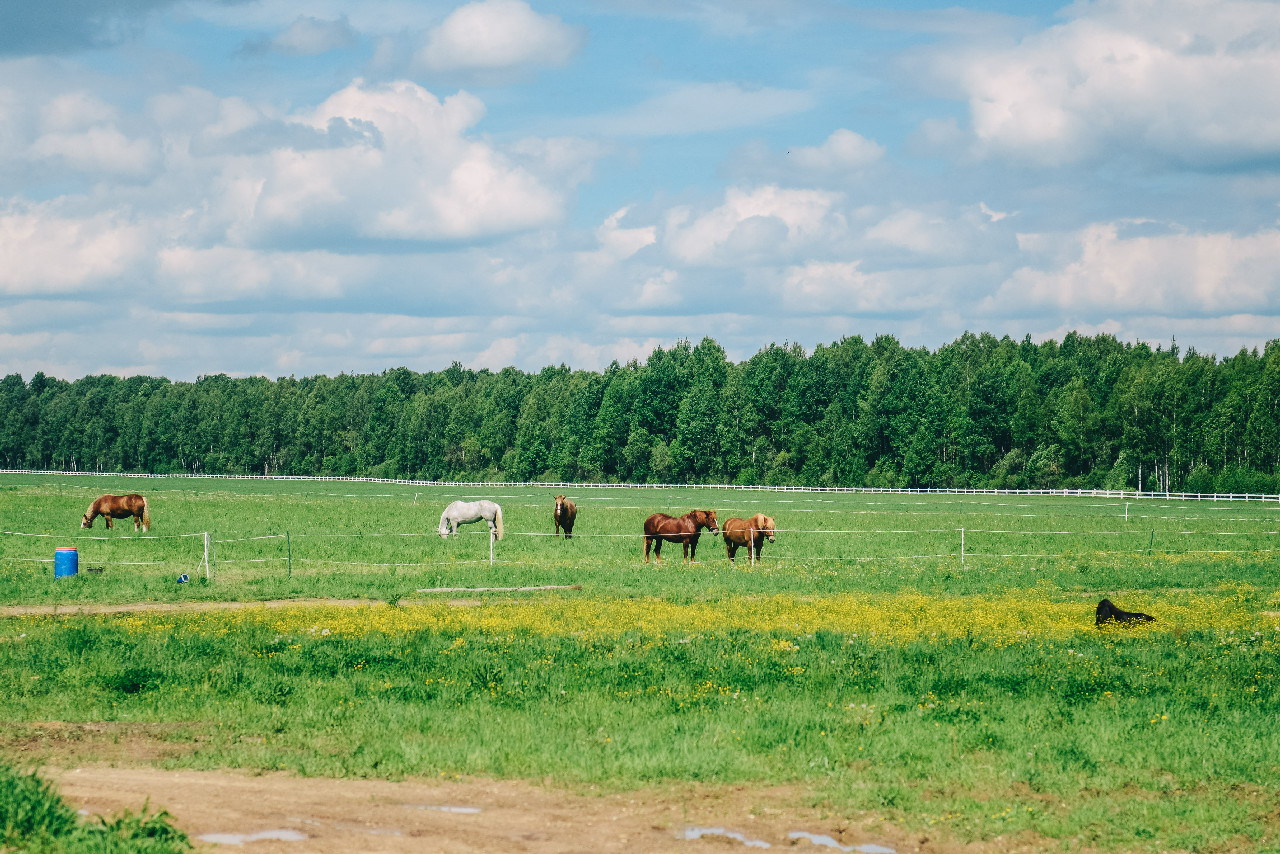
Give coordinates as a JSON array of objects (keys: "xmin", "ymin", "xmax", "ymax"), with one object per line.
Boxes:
[{"xmin": 0, "ymin": 616, "xmax": 1280, "ymax": 850}]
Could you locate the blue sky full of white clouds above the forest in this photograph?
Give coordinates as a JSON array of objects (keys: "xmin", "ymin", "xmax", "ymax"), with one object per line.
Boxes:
[{"xmin": 0, "ymin": 0, "xmax": 1280, "ymax": 380}]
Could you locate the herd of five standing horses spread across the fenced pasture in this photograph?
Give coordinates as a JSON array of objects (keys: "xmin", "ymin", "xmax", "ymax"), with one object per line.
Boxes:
[{"xmin": 81, "ymin": 493, "xmax": 776, "ymax": 563}]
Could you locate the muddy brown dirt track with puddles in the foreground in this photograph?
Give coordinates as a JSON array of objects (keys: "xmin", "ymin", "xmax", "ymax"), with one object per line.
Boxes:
[{"xmin": 44, "ymin": 767, "xmax": 967, "ymax": 854}]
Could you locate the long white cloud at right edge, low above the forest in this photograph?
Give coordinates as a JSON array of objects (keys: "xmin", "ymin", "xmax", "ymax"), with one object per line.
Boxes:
[{"xmin": 982, "ymin": 223, "xmax": 1280, "ymax": 316}]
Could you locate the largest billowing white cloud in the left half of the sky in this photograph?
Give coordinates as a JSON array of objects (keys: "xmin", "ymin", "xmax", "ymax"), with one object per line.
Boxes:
[{"xmin": 192, "ymin": 81, "xmax": 583, "ymax": 245}]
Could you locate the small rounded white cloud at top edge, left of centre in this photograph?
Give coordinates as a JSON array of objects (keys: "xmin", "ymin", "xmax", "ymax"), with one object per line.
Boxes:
[{"xmin": 417, "ymin": 0, "xmax": 582, "ymax": 72}]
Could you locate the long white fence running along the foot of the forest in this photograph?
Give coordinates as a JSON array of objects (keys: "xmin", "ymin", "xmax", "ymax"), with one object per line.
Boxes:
[{"xmin": 0, "ymin": 469, "xmax": 1280, "ymax": 503}]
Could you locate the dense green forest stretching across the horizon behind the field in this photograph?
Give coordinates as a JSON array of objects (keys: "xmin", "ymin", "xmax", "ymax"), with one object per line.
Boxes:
[{"xmin": 0, "ymin": 333, "xmax": 1280, "ymax": 493}]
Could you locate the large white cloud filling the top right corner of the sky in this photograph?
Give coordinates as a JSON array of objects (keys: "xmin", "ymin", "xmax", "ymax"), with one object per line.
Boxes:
[{"xmin": 936, "ymin": 0, "xmax": 1280, "ymax": 165}]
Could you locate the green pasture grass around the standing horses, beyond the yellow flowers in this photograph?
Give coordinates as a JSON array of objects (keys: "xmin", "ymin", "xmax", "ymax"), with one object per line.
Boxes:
[{"xmin": 0, "ymin": 475, "xmax": 1280, "ymax": 604}]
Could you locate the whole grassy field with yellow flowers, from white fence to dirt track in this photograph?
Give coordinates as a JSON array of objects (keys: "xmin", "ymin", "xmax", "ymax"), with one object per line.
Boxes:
[{"xmin": 0, "ymin": 476, "xmax": 1280, "ymax": 850}]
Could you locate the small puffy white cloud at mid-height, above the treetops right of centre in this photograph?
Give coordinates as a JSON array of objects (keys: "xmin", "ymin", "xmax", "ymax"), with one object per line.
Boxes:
[{"xmin": 664, "ymin": 186, "xmax": 846, "ymax": 265}]
